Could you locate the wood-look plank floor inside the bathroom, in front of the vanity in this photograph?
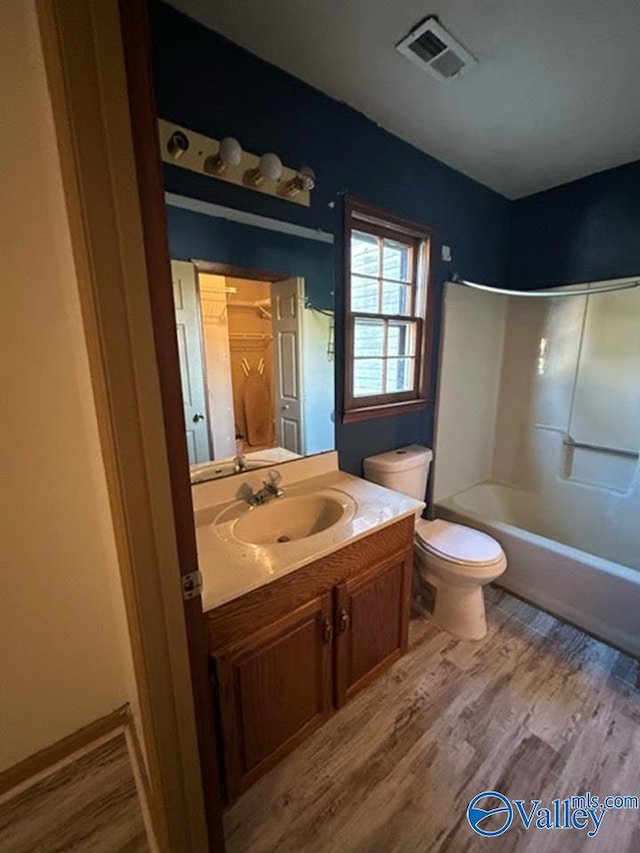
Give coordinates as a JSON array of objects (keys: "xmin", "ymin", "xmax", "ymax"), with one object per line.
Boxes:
[{"xmin": 225, "ymin": 589, "xmax": 640, "ymax": 853}]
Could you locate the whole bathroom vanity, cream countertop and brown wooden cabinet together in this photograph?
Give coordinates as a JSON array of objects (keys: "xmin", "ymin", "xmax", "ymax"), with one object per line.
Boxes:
[{"xmin": 194, "ymin": 453, "xmax": 422, "ymax": 801}]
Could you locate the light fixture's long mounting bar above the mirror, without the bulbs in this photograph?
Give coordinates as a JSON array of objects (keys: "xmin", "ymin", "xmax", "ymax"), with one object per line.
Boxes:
[{"xmin": 158, "ymin": 118, "xmax": 311, "ymax": 207}]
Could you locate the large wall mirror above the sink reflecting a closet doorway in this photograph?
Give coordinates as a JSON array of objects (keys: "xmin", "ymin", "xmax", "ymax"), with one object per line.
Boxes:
[{"xmin": 167, "ymin": 195, "xmax": 335, "ymax": 483}]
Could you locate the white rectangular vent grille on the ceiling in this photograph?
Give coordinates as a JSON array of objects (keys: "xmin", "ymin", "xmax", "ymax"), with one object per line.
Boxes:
[{"xmin": 396, "ymin": 17, "xmax": 478, "ymax": 82}]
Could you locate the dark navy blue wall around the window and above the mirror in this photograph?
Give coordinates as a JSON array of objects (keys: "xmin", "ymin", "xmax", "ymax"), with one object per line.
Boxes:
[{"xmin": 150, "ymin": 0, "xmax": 510, "ymax": 473}]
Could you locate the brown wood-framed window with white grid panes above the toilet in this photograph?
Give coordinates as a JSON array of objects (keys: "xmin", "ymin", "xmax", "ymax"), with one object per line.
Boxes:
[{"xmin": 343, "ymin": 198, "xmax": 433, "ymax": 422}]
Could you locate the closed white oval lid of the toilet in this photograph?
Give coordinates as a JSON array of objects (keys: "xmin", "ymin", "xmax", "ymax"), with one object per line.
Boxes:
[{"xmin": 416, "ymin": 518, "xmax": 503, "ymax": 565}]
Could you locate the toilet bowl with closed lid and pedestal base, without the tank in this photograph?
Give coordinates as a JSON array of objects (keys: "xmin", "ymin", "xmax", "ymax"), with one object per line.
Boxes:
[{"xmin": 414, "ymin": 519, "xmax": 507, "ymax": 640}]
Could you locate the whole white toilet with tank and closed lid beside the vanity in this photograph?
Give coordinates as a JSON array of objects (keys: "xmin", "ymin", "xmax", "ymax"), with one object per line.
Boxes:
[{"xmin": 364, "ymin": 444, "xmax": 507, "ymax": 640}]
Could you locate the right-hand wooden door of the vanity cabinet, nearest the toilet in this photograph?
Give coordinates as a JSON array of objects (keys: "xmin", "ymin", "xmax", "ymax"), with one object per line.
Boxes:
[{"xmin": 335, "ymin": 553, "xmax": 412, "ymax": 707}]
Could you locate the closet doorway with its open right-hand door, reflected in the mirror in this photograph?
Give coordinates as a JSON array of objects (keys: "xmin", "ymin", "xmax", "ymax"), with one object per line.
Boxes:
[{"xmin": 198, "ymin": 272, "xmax": 304, "ymax": 461}]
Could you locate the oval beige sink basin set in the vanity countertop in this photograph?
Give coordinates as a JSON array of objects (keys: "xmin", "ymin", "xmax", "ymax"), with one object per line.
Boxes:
[{"xmin": 213, "ymin": 490, "xmax": 355, "ymax": 546}]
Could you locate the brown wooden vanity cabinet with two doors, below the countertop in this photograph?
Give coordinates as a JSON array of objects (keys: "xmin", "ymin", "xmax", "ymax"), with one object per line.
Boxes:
[{"xmin": 207, "ymin": 517, "xmax": 414, "ymax": 802}]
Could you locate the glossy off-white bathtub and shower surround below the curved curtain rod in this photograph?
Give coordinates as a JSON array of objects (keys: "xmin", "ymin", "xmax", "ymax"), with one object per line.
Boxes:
[{"xmin": 433, "ymin": 284, "xmax": 640, "ymax": 655}]
